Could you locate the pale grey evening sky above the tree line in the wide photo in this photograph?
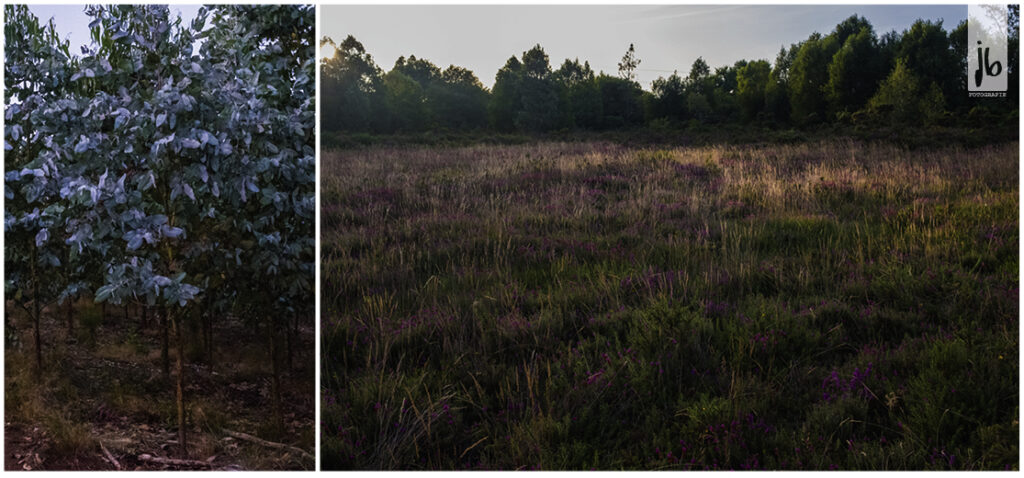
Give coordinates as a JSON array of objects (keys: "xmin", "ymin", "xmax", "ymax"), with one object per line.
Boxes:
[{"xmin": 321, "ymin": 5, "xmax": 967, "ymax": 90}]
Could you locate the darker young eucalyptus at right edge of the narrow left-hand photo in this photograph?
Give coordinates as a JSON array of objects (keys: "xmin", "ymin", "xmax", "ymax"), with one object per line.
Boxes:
[{"xmin": 197, "ymin": 5, "xmax": 315, "ymax": 436}]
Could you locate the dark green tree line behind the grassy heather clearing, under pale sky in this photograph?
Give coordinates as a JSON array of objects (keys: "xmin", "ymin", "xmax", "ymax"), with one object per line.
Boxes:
[{"xmin": 321, "ymin": 9, "xmax": 1019, "ymax": 134}]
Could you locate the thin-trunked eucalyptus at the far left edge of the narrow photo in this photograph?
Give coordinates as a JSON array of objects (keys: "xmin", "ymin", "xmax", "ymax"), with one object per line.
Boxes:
[{"xmin": 4, "ymin": 5, "xmax": 77, "ymax": 377}]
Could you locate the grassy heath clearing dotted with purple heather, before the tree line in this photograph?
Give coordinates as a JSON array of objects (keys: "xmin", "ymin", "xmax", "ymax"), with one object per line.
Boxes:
[{"xmin": 321, "ymin": 141, "xmax": 1019, "ymax": 470}]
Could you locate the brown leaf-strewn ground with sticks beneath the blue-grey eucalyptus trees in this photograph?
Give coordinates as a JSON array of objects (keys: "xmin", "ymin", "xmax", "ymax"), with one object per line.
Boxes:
[{"xmin": 4, "ymin": 307, "xmax": 315, "ymax": 470}]
